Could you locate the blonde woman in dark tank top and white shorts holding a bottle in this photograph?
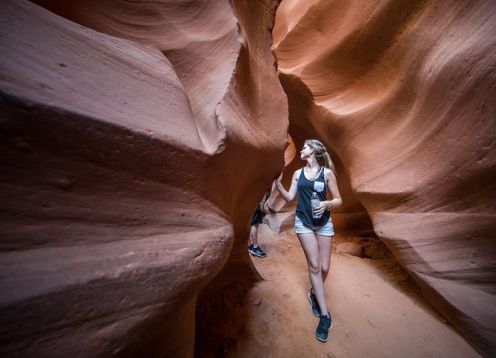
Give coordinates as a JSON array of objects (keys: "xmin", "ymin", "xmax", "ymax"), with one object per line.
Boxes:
[{"xmin": 276, "ymin": 139, "xmax": 342, "ymax": 342}]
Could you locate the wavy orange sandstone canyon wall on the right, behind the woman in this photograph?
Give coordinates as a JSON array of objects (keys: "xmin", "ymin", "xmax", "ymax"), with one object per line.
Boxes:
[{"xmin": 273, "ymin": 0, "xmax": 496, "ymax": 356}]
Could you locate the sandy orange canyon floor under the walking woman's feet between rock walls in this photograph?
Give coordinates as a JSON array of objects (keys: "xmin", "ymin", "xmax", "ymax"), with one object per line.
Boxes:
[{"xmin": 233, "ymin": 224, "xmax": 480, "ymax": 358}]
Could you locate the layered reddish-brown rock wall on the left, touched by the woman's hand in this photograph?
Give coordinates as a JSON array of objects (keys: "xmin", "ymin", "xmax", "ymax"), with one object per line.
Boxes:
[{"xmin": 0, "ymin": 0, "xmax": 287, "ymax": 357}]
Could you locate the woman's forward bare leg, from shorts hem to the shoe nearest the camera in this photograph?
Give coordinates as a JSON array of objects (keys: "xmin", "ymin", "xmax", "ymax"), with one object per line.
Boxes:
[{"xmin": 297, "ymin": 233, "xmax": 329, "ymax": 316}]
